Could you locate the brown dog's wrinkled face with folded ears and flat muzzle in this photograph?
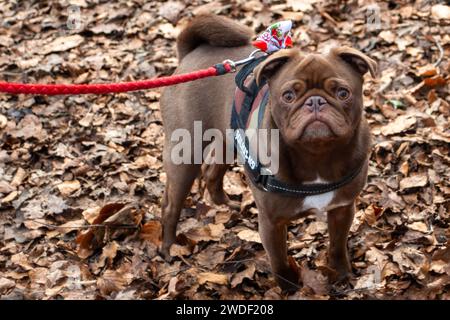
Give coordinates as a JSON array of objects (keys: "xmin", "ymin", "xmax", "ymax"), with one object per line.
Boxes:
[{"xmin": 255, "ymin": 47, "xmax": 376, "ymax": 152}]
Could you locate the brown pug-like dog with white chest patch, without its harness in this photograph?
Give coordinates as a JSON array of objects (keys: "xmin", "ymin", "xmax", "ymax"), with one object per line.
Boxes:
[{"xmin": 161, "ymin": 15, "xmax": 377, "ymax": 290}]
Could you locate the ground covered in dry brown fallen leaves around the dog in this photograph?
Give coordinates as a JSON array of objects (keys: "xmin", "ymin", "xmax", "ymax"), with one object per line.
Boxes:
[{"xmin": 0, "ymin": 0, "xmax": 450, "ymax": 299}]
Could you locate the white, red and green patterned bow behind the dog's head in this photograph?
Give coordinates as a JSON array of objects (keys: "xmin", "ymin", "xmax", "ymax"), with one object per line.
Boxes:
[{"xmin": 252, "ymin": 20, "xmax": 292, "ymax": 53}]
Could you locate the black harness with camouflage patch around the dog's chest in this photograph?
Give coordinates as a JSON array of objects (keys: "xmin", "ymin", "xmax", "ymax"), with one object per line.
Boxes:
[{"xmin": 231, "ymin": 56, "xmax": 364, "ymax": 197}]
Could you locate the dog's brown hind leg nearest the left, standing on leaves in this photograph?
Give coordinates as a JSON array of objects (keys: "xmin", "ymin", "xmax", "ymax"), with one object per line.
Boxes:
[{"xmin": 160, "ymin": 157, "xmax": 200, "ymax": 260}]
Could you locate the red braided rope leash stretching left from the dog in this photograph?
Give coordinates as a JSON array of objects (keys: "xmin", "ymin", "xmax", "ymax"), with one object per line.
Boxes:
[{"xmin": 0, "ymin": 61, "xmax": 236, "ymax": 95}]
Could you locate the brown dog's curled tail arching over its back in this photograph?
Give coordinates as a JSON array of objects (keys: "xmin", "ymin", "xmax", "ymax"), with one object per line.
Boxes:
[{"xmin": 177, "ymin": 14, "xmax": 253, "ymax": 61}]
